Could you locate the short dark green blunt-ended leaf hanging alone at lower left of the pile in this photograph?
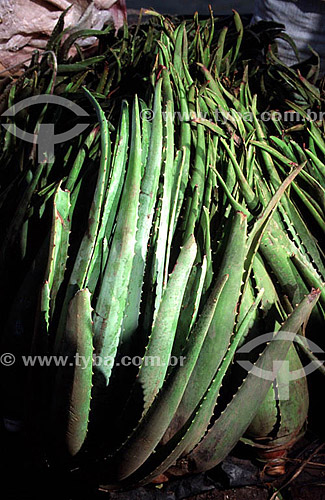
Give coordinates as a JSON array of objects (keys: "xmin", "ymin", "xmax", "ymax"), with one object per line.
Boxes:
[{"xmin": 51, "ymin": 289, "xmax": 93, "ymax": 456}]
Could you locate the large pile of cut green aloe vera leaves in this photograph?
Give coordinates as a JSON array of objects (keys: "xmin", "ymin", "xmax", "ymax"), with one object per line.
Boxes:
[{"xmin": 0, "ymin": 6, "xmax": 325, "ymax": 488}]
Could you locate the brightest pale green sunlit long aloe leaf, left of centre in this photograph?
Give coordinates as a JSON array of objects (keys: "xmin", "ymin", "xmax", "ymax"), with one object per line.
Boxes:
[{"xmin": 94, "ymin": 98, "xmax": 141, "ymax": 387}]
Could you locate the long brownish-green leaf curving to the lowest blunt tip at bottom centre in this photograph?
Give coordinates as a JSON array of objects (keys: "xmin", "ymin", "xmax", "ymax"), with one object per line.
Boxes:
[{"xmin": 114, "ymin": 276, "xmax": 227, "ymax": 480}]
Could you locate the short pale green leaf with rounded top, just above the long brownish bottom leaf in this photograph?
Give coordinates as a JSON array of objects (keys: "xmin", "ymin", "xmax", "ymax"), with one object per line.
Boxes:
[{"xmin": 138, "ymin": 236, "xmax": 197, "ymax": 412}]
